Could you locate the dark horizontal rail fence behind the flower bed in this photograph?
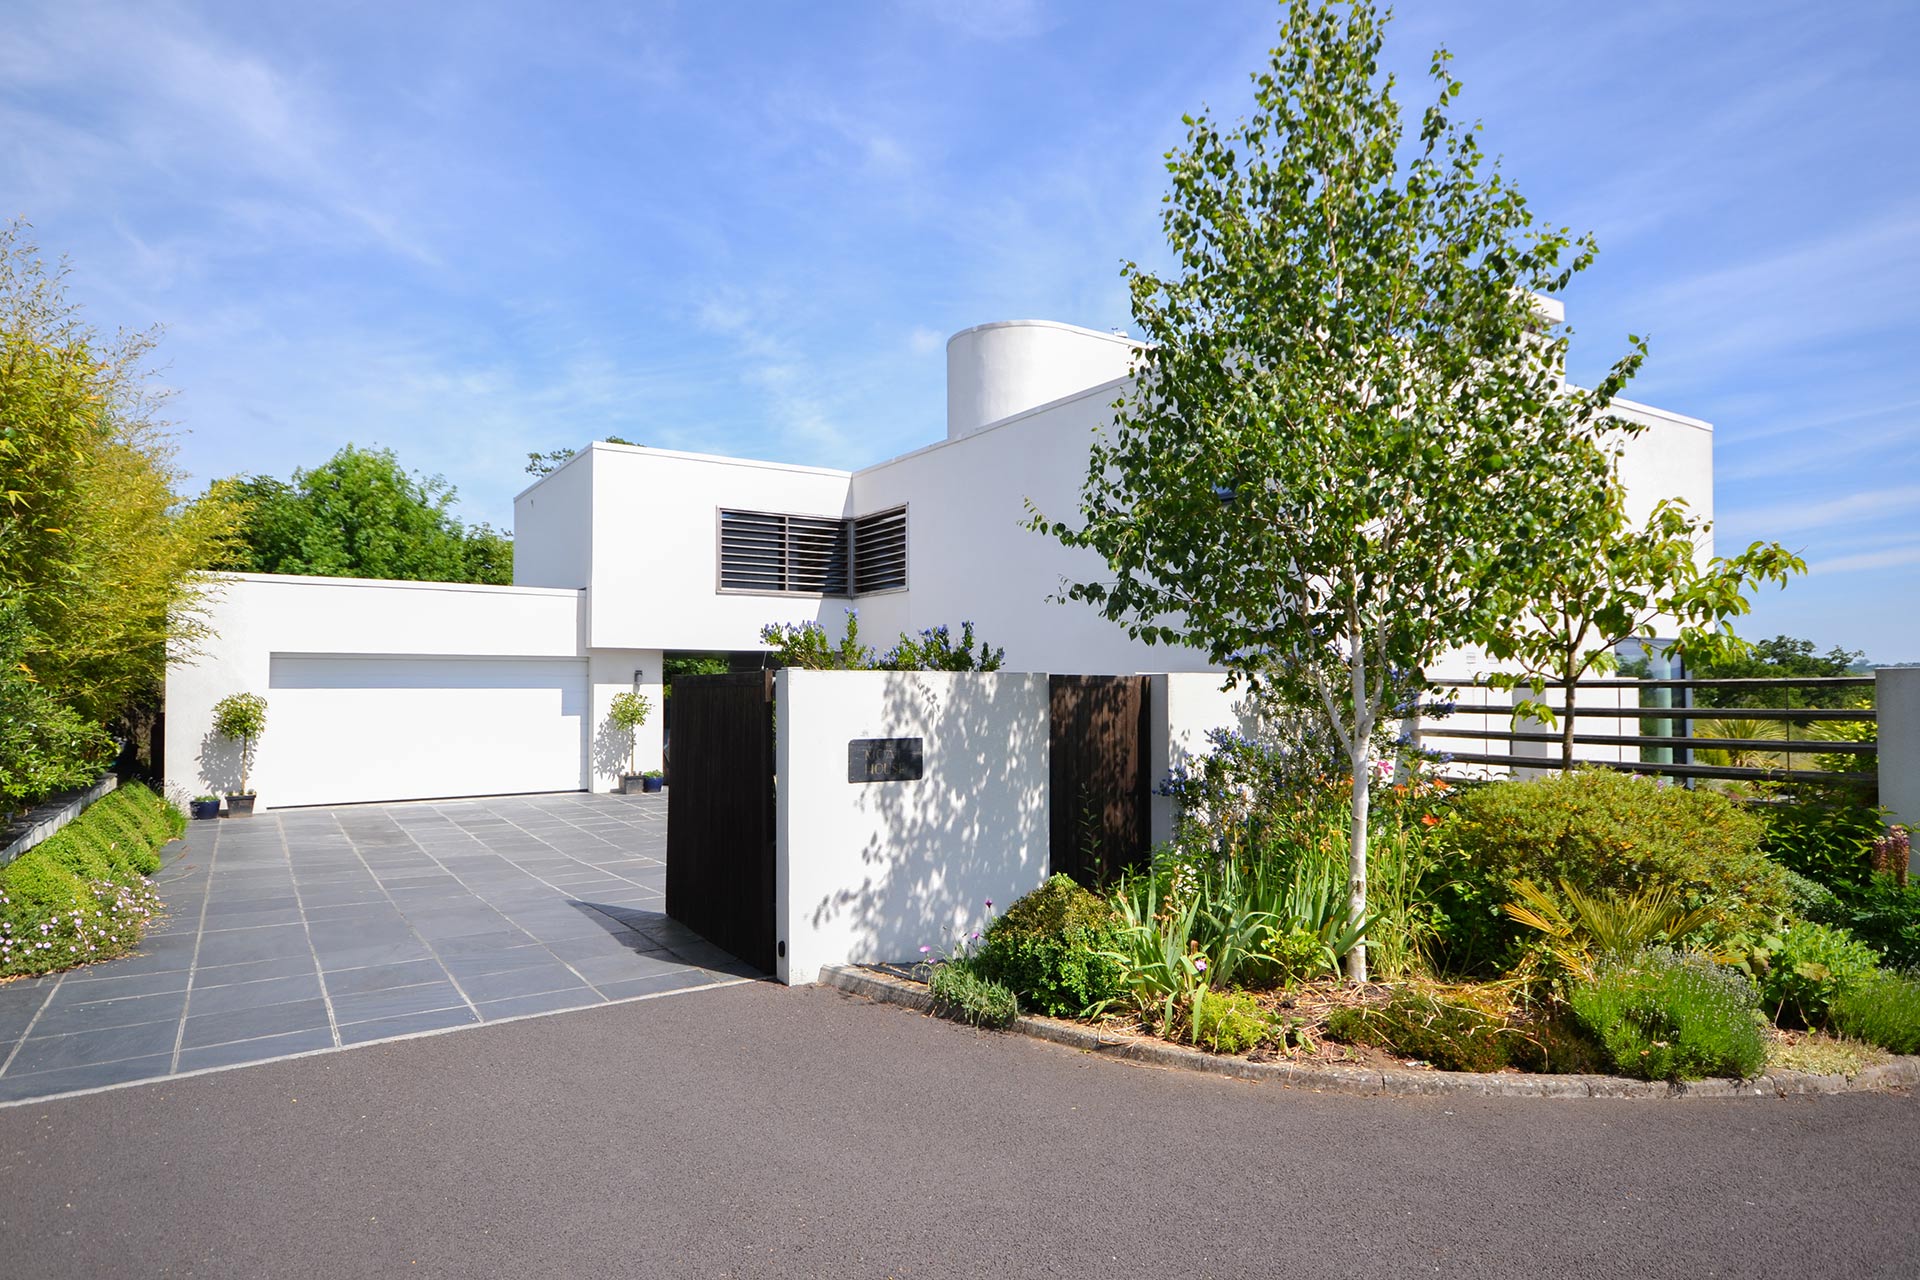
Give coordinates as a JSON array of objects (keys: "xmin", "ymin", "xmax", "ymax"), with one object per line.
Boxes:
[{"xmin": 1417, "ymin": 676, "xmax": 1880, "ymax": 785}]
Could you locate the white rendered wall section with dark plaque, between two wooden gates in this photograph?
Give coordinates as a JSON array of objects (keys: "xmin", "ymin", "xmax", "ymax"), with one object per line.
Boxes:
[{"xmin": 774, "ymin": 670, "xmax": 1050, "ymax": 983}]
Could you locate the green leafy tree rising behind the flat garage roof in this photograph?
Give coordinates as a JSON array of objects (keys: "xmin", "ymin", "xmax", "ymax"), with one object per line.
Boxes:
[{"xmin": 207, "ymin": 443, "xmax": 513, "ymax": 585}]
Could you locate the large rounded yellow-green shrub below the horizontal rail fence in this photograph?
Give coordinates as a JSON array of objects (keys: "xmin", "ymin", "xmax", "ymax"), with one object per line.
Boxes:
[{"xmin": 1450, "ymin": 770, "xmax": 1791, "ymax": 938}]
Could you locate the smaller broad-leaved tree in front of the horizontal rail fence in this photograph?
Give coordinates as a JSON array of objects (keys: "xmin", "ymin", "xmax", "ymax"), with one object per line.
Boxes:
[{"xmin": 1480, "ymin": 476, "xmax": 1807, "ymax": 770}]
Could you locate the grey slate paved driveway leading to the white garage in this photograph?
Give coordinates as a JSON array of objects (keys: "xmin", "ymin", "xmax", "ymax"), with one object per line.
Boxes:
[{"xmin": 0, "ymin": 794, "xmax": 756, "ymax": 1102}]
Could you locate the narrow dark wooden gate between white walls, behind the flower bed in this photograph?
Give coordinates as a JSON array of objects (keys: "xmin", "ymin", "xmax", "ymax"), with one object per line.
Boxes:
[{"xmin": 1048, "ymin": 676, "xmax": 1152, "ymax": 885}]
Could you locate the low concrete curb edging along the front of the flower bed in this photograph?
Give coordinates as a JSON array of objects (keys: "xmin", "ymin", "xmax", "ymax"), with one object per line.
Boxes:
[{"xmin": 820, "ymin": 965, "xmax": 1920, "ymax": 1098}]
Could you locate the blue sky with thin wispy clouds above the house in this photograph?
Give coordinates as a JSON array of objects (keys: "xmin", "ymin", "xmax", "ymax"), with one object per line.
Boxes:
[{"xmin": 0, "ymin": 0, "xmax": 1920, "ymax": 660}]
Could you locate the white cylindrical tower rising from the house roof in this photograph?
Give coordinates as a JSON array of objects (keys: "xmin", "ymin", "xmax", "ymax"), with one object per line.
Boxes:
[{"xmin": 947, "ymin": 320, "xmax": 1140, "ymax": 439}]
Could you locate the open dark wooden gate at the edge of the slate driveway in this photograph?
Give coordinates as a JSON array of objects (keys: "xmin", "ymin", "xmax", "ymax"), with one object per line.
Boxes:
[{"xmin": 666, "ymin": 672, "xmax": 776, "ymax": 973}]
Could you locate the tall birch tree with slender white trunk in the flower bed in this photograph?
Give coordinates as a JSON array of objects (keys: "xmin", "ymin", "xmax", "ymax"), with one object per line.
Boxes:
[{"xmin": 1035, "ymin": 2, "xmax": 1642, "ymax": 981}]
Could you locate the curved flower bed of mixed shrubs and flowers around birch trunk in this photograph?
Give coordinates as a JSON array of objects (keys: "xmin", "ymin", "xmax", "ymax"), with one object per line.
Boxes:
[{"xmin": 917, "ymin": 721, "xmax": 1920, "ymax": 1082}]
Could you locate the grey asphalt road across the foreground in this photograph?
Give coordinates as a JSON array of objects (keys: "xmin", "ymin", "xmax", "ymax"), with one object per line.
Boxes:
[{"xmin": 0, "ymin": 984, "xmax": 1920, "ymax": 1280}]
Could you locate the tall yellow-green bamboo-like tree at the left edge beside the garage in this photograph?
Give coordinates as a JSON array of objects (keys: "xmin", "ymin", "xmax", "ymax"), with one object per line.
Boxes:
[{"xmin": 0, "ymin": 223, "xmax": 238, "ymax": 800}]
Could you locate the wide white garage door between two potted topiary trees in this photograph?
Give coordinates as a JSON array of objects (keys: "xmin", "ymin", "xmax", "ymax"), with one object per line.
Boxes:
[{"xmin": 253, "ymin": 654, "xmax": 588, "ymax": 806}]
